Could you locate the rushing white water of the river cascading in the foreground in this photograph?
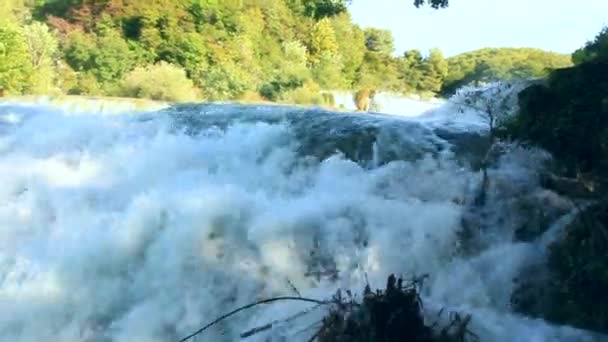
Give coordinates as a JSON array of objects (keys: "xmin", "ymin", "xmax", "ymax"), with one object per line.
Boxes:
[{"xmin": 0, "ymin": 99, "xmax": 604, "ymax": 342}]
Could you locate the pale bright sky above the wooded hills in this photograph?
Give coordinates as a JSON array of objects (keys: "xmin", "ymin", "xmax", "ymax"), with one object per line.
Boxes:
[{"xmin": 350, "ymin": 0, "xmax": 608, "ymax": 56}]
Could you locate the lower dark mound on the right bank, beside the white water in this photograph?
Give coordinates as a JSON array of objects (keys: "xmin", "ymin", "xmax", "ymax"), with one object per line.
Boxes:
[{"xmin": 511, "ymin": 201, "xmax": 608, "ymax": 333}]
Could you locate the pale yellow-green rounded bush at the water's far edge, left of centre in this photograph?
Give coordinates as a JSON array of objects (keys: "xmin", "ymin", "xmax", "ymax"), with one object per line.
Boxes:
[{"xmin": 117, "ymin": 62, "xmax": 199, "ymax": 102}]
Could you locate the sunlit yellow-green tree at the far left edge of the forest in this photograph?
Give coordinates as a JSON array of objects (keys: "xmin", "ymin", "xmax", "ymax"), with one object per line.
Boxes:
[{"xmin": 0, "ymin": 25, "xmax": 32, "ymax": 94}]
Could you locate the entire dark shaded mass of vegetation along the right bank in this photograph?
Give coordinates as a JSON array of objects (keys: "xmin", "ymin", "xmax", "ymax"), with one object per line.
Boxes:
[{"xmin": 496, "ymin": 29, "xmax": 608, "ymax": 333}]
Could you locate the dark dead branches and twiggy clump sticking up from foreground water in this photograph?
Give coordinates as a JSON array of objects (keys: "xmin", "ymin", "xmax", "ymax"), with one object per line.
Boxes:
[{"xmin": 179, "ymin": 275, "xmax": 478, "ymax": 342}]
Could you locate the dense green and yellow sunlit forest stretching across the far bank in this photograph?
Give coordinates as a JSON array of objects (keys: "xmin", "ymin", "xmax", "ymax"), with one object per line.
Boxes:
[{"xmin": 0, "ymin": 0, "xmax": 571, "ymax": 104}]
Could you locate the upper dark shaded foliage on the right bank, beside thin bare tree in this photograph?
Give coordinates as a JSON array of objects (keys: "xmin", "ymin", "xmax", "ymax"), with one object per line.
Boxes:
[{"xmin": 510, "ymin": 60, "xmax": 608, "ymax": 176}]
